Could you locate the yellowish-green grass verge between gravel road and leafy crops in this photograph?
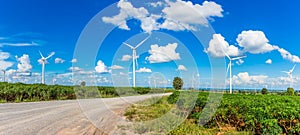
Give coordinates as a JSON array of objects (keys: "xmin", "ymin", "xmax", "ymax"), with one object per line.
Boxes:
[{"xmin": 124, "ymin": 97, "xmax": 250, "ymax": 135}]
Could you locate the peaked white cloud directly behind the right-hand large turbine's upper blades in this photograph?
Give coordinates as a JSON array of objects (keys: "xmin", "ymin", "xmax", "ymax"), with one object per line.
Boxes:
[{"xmin": 204, "ymin": 34, "xmax": 241, "ymax": 57}]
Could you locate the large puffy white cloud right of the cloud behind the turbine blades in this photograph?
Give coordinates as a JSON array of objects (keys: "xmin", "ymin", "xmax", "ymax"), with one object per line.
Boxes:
[{"xmin": 236, "ymin": 30, "xmax": 277, "ymax": 54}]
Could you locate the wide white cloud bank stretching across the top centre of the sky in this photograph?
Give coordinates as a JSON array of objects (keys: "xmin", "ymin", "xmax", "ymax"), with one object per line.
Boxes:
[{"xmin": 102, "ymin": 0, "xmax": 223, "ymax": 33}]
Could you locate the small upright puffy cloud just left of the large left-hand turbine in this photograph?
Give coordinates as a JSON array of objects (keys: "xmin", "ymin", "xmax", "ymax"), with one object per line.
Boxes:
[{"xmin": 16, "ymin": 54, "xmax": 32, "ymax": 72}]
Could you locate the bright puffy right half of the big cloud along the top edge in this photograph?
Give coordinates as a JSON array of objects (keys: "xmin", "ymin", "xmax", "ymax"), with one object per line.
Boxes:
[{"xmin": 161, "ymin": 0, "xmax": 223, "ymax": 31}]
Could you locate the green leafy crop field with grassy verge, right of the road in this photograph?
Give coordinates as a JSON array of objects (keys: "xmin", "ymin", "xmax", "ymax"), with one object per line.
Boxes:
[{"xmin": 125, "ymin": 92, "xmax": 300, "ymax": 135}]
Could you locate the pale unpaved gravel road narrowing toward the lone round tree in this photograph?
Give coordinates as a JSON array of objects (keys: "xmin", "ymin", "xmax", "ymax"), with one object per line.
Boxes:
[{"xmin": 0, "ymin": 94, "xmax": 169, "ymax": 135}]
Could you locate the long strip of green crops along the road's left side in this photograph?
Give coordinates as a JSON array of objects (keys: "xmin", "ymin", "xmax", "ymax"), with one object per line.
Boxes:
[{"xmin": 0, "ymin": 82, "xmax": 170, "ymax": 102}]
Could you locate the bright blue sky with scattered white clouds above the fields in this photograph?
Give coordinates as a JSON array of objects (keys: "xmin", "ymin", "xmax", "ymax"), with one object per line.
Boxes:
[{"xmin": 0, "ymin": 0, "xmax": 300, "ymax": 88}]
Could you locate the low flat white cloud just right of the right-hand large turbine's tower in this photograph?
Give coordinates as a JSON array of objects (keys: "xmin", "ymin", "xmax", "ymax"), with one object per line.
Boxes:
[{"xmin": 232, "ymin": 72, "xmax": 268, "ymax": 85}]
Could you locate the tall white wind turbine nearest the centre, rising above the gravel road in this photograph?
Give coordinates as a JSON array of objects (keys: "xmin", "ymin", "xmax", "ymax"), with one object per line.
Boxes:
[{"xmin": 123, "ymin": 35, "xmax": 150, "ymax": 87}]
